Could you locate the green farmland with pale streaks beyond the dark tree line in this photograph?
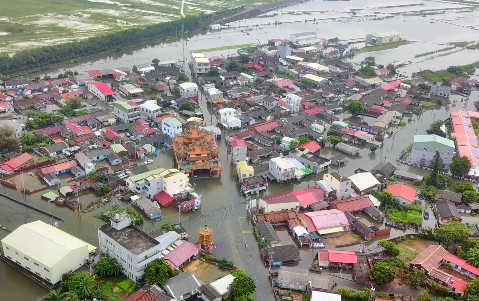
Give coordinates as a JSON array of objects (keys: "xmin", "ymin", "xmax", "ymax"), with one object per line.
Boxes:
[{"xmin": 0, "ymin": 0, "xmax": 277, "ymax": 54}]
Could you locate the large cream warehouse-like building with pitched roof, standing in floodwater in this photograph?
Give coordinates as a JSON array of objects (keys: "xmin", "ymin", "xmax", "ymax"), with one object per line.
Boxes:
[{"xmin": 2, "ymin": 221, "xmax": 95, "ymax": 284}]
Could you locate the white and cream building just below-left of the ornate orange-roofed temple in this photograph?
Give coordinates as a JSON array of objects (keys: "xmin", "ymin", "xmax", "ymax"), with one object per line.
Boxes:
[{"xmin": 126, "ymin": 168, "xmax": 192, "ymax": 198}]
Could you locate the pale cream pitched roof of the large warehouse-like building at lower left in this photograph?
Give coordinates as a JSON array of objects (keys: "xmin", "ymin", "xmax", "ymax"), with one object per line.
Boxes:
[{"xmin": 2, "ymin": 221, "xmax": 96, "ymax": 267}]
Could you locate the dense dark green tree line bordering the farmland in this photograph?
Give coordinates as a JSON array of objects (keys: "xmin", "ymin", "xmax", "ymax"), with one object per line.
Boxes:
[{"xmin": 0, "ymin": 14, "xmax": 205, "ymax": 74}]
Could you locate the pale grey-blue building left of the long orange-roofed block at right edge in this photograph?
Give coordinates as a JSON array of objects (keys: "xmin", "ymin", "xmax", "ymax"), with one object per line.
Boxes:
[{"xmin": 410, "ymin": 135, "xmax": 456, "ymax": 169}]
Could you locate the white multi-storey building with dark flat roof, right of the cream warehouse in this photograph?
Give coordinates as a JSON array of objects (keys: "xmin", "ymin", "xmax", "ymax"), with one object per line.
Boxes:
[{"xmin": 98, "ymin": 213, "xmax": 163, "ymax": 282}]
